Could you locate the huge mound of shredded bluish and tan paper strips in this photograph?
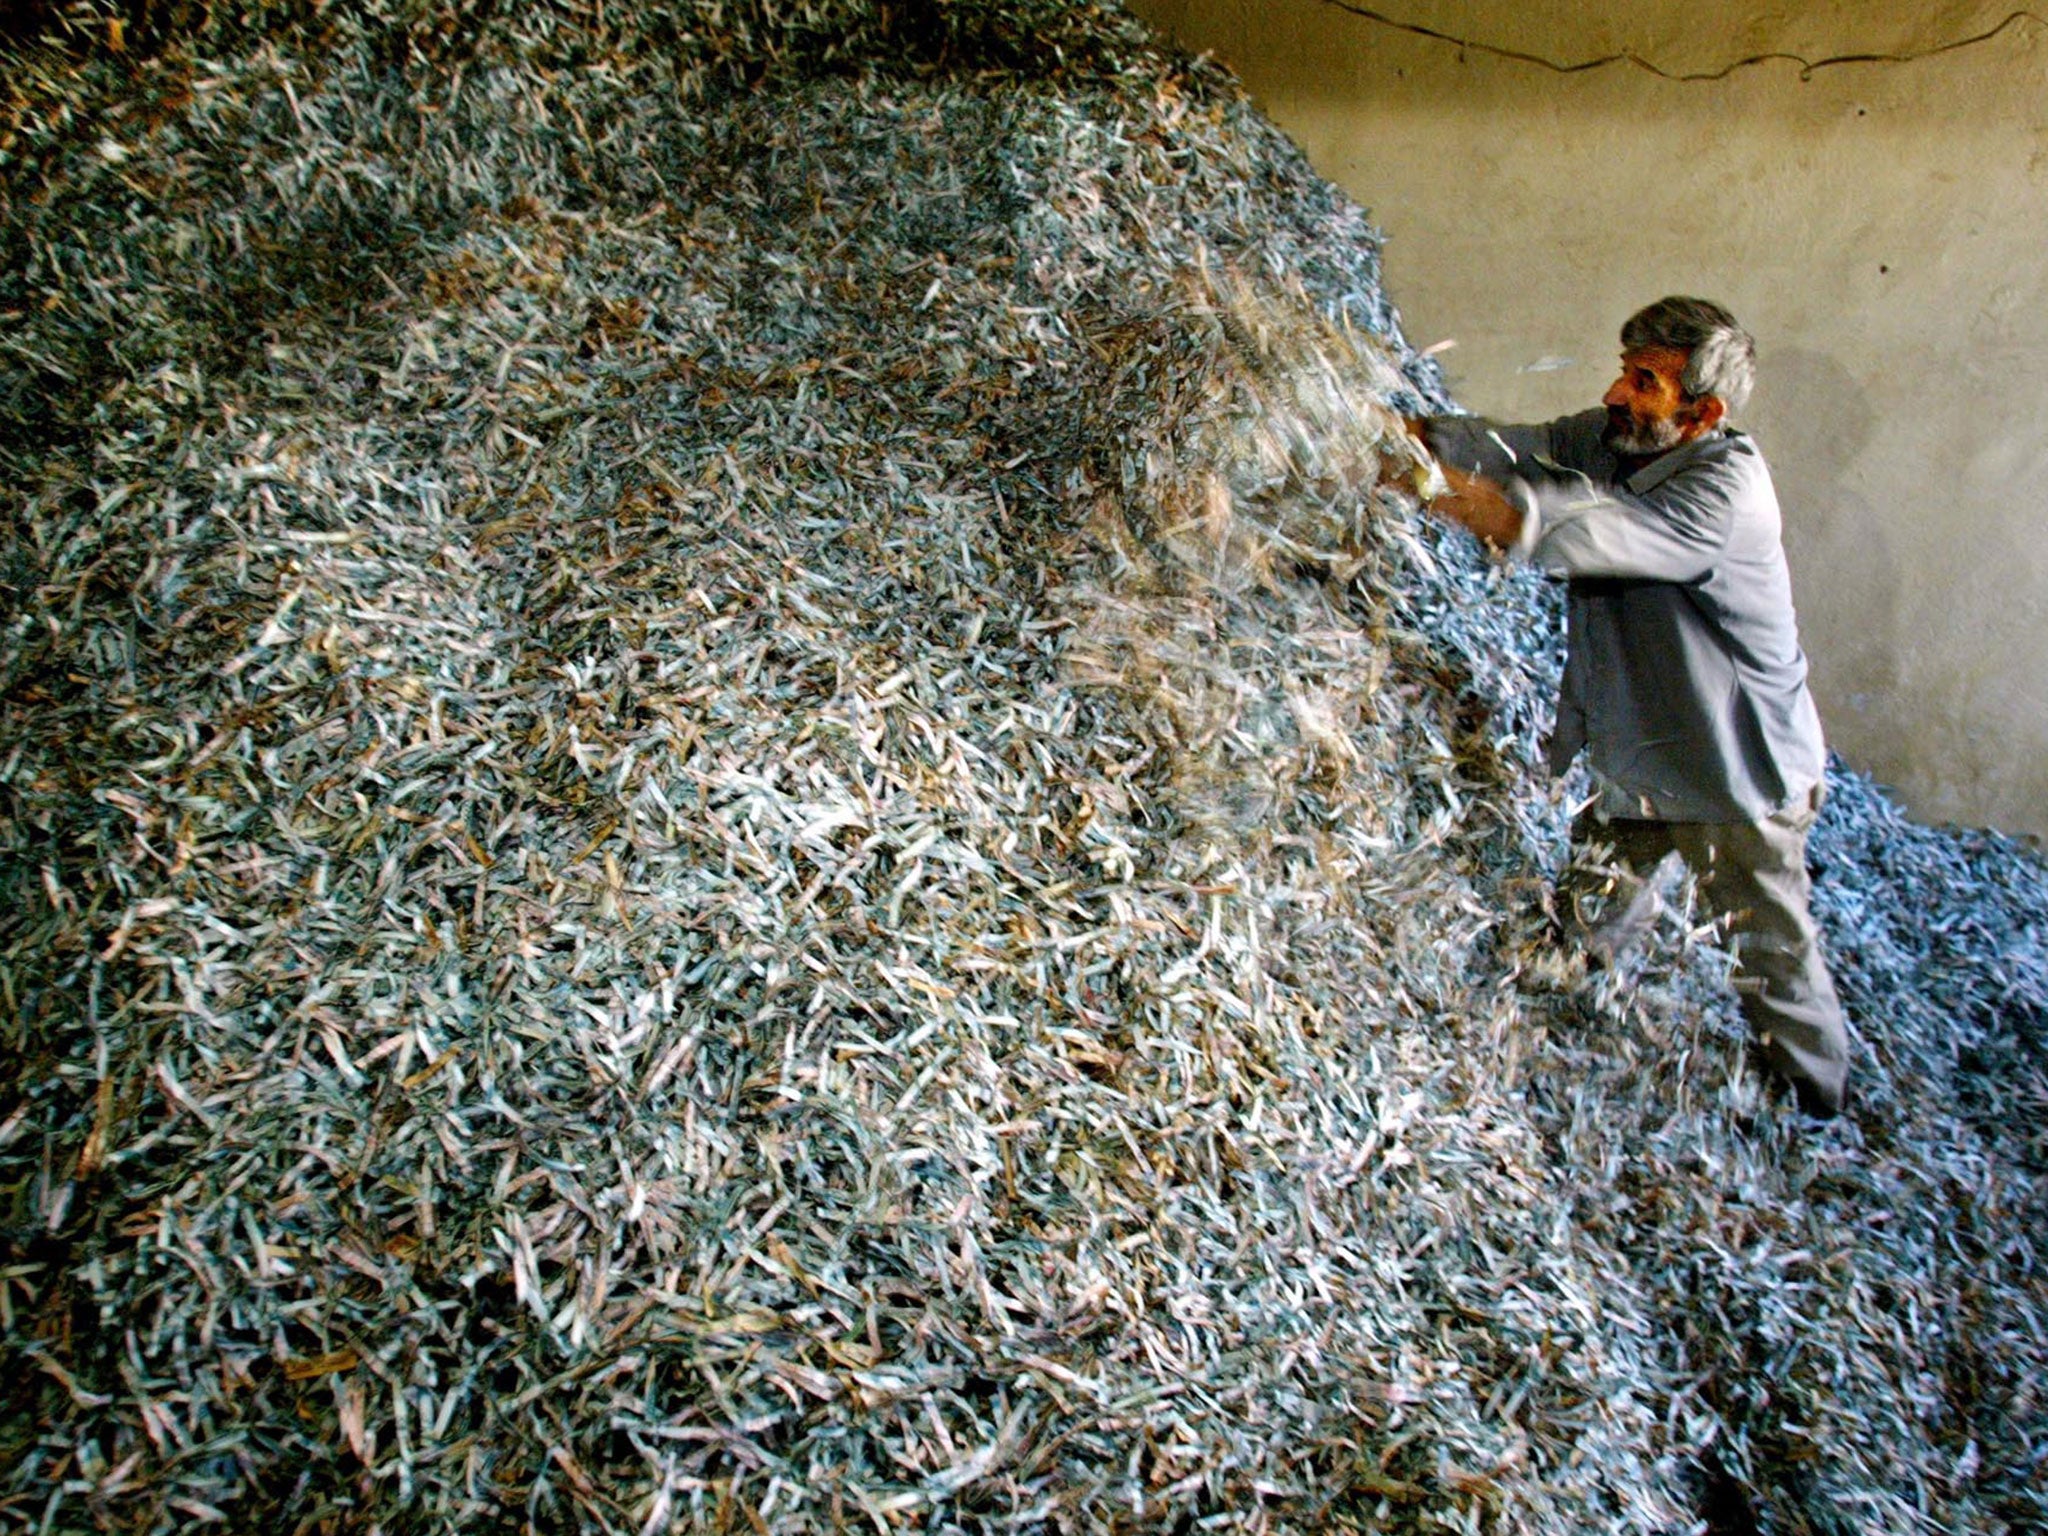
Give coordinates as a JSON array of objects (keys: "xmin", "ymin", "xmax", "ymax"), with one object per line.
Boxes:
[{"xmin": 0, "ymin": 0, "xmax": 2048, "ymax": 1536}]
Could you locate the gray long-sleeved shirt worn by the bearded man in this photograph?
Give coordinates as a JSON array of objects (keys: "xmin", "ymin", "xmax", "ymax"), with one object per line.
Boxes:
[{"xmin": 1430, "ymin": 410, "xmax": 1825, "ymax": 821}]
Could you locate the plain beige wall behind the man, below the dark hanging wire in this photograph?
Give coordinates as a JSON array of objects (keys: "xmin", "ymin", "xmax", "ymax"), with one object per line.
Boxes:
[{"xmin": 1130, "ymin": 0, "xmax": 2048, "ymax": 834}]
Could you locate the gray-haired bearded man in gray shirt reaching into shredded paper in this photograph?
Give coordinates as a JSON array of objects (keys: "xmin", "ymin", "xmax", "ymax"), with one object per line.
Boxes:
[{"xmin": 1409, "ymin": 297, "xmax": 1849, "ymax": 1116}]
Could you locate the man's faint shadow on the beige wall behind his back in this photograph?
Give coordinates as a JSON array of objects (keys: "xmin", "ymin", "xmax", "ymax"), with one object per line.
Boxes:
[{"xmin": 1755, "ymin": 348, "xmax": 1907, "ymax": 757}]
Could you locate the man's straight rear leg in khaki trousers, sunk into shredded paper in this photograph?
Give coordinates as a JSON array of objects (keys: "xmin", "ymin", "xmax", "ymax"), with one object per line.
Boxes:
[{"xmin": 1671, "ymin": 786, "xmax": 1849, "ymax": 1114}]
